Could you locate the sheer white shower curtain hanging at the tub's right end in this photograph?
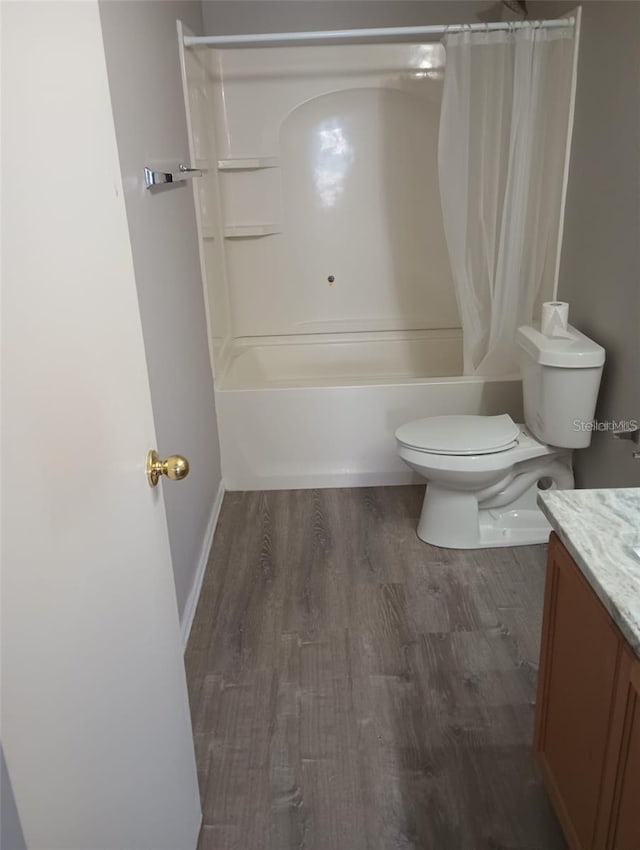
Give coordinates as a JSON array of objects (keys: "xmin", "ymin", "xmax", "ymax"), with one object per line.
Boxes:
[{"xmin": 438, "ymin": 25, "xmax": 574, "ymax": 376}]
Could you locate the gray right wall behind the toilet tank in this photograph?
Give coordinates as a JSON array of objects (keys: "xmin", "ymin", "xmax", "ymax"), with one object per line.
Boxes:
[{"xmin": 532, "ymin": 2, "xmax": 640, "ymax": 487}]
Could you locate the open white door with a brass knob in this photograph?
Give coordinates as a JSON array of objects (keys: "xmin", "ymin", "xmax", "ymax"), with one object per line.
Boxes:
[{"xmin": 1, "ymin": 0, "xmax": 200, "ymax": 850}]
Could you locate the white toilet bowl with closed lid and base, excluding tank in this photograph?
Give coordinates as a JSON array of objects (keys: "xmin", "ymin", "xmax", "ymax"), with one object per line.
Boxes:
[{"xmin": 396, "ymin": 415, "xmax": 574, "ymax": 549}]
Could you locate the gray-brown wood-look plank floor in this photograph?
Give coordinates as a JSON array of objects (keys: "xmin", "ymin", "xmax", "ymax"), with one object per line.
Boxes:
[{"xmin": 186, "ymin": 487, "xmax": 566, "ymax": 850}]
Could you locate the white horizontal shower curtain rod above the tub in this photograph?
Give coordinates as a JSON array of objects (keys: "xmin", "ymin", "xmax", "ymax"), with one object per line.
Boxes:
[{"xmin": 184, "ymin": 18, "xmax": 575, "ymax": 47}]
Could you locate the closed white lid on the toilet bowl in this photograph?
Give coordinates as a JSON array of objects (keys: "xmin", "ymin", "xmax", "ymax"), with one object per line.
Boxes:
[{"xmin": 396, "ymin": 413, "xmax": 520, "ymax": 455}]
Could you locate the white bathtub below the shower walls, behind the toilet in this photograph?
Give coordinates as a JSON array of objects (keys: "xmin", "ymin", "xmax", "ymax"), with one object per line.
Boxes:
[{"xmin": 216, "ymin": 329, "xmax": 522, "ymax": 490}]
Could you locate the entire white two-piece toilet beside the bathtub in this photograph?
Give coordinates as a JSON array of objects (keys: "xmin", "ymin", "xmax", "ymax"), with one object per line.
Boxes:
[{"xmin": 396, "ymin": 325, "xmax": 605, "ymax": 549}]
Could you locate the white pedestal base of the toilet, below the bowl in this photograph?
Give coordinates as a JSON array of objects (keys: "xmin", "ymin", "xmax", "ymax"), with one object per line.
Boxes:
[{"xmin": 418, "ymin": 482, "xmax": 551, "ymax": 549}]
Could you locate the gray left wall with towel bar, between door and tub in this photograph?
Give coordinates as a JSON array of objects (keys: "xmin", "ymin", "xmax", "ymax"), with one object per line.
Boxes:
[{"xmin": 100, "ymin": 0, "xmax": 220, "ymax": 617}]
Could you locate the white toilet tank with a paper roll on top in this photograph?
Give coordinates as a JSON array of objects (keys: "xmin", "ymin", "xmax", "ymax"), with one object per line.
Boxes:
[{"xmin": 516, "ymin": 325, "xmax": 605, "ymax": 449}]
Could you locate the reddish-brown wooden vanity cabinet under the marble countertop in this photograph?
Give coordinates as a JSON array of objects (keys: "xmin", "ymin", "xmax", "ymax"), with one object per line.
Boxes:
[{"xmin": 535, "ymin": 534, "xmax": 640, "ymax": 850}]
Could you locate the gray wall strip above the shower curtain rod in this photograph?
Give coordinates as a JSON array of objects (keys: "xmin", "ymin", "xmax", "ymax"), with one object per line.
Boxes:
[{"xmin": 202, "ymin": 0, "xmax": 495, "ymax": 35}]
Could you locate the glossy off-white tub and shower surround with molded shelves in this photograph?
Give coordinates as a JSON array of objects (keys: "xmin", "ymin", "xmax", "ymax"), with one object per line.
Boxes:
[{"xmin": 180, "ymin": 26, "xmax": 572, "ymax": 490}]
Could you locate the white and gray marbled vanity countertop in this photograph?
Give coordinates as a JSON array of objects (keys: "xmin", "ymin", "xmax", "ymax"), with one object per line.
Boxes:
[{"xmin": 538, "ymin": 487, "xmax": 640, "ymax": 657}]
